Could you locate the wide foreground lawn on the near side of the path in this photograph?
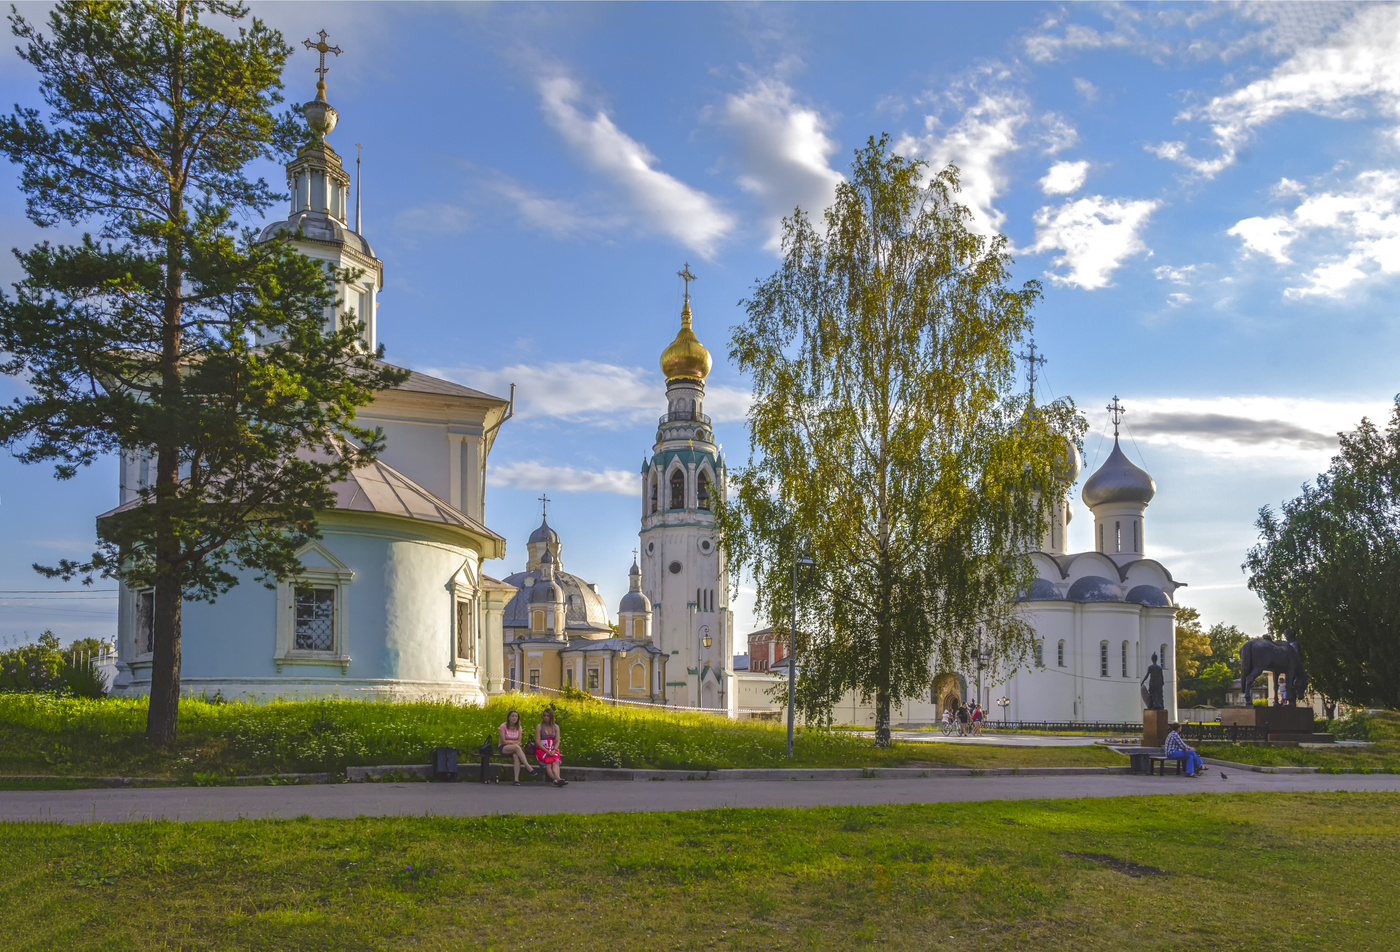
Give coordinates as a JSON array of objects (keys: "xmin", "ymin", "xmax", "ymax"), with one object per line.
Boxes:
[{"xmin": 0, "ymin": 794, "xmax": 1400, "ymax": 952}]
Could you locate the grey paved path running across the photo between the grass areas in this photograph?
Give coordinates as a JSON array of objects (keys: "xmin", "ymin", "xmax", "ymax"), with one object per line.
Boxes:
[{"xmin": 0, "ymin": 767, "xmax": 1400, "ymax": 823}]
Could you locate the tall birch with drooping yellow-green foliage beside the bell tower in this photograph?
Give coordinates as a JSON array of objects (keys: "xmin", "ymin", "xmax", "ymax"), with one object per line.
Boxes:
[{"xmin": 720, "ymin": 136, "xmax": 1084, "ymax": 745}]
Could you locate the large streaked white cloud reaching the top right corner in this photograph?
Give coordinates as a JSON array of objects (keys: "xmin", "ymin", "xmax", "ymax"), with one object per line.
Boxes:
[{"xmin": 1149, "ymin": 4, "xmax": 1400, "ymax": 178}]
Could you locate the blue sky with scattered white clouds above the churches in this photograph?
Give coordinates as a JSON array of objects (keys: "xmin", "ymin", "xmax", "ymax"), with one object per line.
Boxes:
[{"xmin": 0, "ymin": 3, "xmax": 1400, "ymax": 638}]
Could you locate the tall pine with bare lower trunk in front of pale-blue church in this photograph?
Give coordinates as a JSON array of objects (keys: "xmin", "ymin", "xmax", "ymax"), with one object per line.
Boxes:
[{"xmin": 0, "ymin": 0, "xmax": 399, "ymax": 745}]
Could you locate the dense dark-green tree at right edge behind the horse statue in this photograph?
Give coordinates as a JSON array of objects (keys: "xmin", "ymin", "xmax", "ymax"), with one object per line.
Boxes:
[{"xmin": 1245, "ymin": 403, "xmax": 1400, "ymax": 708}]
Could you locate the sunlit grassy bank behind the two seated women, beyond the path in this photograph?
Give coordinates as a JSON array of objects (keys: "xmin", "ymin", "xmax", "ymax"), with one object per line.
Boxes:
[{"xmin": 0, "ymin": 694, "xmax": 1127, "ymax": 784}]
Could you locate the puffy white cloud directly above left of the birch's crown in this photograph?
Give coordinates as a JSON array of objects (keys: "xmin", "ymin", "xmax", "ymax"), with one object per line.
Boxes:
[{"xmin": 717, "ymin": 78, "xmax": 841, "ymax": 251}]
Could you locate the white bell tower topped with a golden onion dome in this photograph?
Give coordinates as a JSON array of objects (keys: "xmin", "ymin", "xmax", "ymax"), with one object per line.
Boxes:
[{"xmin": 640, "ymin": 265, "xmax": 738, "ymax": 715}]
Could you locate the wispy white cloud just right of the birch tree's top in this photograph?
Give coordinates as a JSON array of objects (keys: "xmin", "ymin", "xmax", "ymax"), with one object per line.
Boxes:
[{"xmin": 895, "ymin": 92, "xmax": 1030, "ymax": 234}]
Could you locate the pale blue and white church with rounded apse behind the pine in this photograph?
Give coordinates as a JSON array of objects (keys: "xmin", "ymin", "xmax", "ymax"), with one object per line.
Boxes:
[{"xmin": 106, "ymin": 59, "xmax": 515, "ymax": 701}]
